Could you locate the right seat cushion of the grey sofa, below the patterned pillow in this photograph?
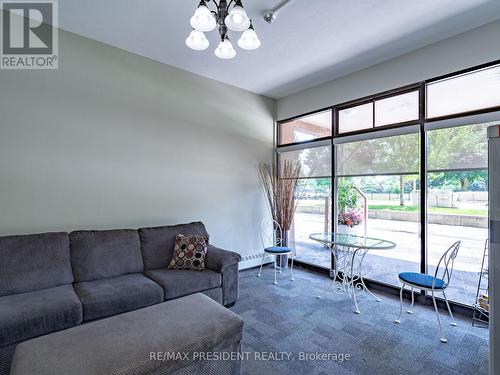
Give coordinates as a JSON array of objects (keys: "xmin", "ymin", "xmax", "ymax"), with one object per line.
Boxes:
[{"xmin": 144, "ymin": 269, "xmax": 222, "ymax": 300}]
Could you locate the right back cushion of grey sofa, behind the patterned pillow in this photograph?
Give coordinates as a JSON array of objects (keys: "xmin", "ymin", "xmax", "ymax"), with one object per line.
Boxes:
[{"xmin": 139, "ymin": 221, "xmax": 208, "ymax": 270}]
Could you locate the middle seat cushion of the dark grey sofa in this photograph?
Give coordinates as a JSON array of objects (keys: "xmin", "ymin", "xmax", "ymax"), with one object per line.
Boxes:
[{"xmin": 74, "ymin": 274, "xmax": 163, "ymax": 321}]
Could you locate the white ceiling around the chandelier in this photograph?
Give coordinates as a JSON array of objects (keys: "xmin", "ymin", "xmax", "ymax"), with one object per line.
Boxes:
[{"xmin": 59, "ymin": 0, "xmax": 500, "ymax": 98}]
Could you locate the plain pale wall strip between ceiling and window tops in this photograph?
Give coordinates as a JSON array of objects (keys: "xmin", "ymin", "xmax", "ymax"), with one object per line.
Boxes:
[{"xmin": 277, "ymin": 21, "xmax": 500, "ymax": 120}]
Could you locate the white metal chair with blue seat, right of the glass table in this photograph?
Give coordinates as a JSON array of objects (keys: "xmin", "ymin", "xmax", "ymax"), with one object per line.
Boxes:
[{"xmin": 394, "ymin": 241, "xmax": 460, "ymax": 343}]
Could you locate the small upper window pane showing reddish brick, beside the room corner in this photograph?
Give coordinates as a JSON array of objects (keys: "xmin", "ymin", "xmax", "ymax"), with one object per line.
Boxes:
[{"xmin": 279, "ymin": 110, "xmax": 332, "ymax": 145}]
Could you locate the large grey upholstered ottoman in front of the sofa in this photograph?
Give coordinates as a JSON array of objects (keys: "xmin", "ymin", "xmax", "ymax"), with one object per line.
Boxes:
[{"xmin": 11, "ymin": 293, "xmax": 243, "ymax": 375}]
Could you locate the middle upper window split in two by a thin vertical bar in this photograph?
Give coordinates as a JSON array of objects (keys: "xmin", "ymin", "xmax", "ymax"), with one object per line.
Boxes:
[{"xmin": 339, "ymin": 90, "xmax": 420, "ymax": 134}]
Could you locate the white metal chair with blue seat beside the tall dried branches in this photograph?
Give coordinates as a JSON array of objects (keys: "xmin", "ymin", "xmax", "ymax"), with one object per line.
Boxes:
[{"xmin": 257, "ymin": 220, "xmax": 294, "ymax": 285}]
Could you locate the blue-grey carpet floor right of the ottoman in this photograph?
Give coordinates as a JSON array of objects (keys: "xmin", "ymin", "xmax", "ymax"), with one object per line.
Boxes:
[{"xmin": 231, "ymin": 266, "xmax": 488, "ymax": 375}]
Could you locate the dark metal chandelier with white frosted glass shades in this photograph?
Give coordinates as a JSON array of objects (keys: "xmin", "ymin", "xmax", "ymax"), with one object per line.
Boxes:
[{"xmin": 186, "ymin": 0, "xmax": 260, "ymax": 59}]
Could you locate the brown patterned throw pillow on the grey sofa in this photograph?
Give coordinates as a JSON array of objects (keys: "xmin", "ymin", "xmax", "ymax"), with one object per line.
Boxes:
[{"xmin": 168, "ymin": 234, "xmax": 208, "ymax": 271}]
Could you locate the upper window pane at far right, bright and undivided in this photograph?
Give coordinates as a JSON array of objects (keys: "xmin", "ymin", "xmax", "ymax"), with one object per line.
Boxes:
[{"xmin": 427, "ymin": 65, "xmax": 500, "ymax": 118}]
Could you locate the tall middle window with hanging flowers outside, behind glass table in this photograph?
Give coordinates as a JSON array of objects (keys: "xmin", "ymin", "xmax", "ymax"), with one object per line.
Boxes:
[{"xmin": 336, "ymin": 133, "xmax": 421, "ymax": 287}]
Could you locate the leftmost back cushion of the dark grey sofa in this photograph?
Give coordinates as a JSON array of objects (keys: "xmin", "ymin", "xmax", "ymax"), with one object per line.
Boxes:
[{"xmin": 0, "ymin": 233, "xmax": 73, "ymax": 296}]
